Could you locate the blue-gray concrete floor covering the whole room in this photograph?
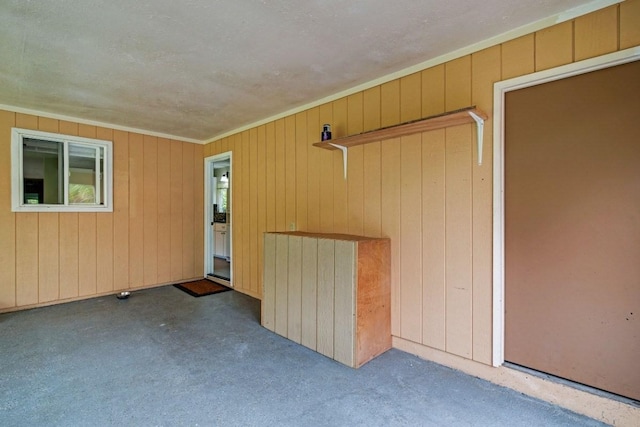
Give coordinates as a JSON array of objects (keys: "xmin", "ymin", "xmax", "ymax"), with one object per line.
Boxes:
[{"xmin": 0, "ymin": 286, "xmax": 601, "ymax": 426}]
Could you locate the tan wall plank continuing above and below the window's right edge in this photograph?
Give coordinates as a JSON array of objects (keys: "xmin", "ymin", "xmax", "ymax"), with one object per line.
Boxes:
[{"xmin": 96, "ymin": 127, "xmax": 113, "ymax": 293}]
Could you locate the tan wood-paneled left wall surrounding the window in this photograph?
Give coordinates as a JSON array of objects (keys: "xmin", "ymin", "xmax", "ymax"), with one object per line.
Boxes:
[{"xmin": 0, "ymin": 110, "xmax": 204, "ymax": 311}]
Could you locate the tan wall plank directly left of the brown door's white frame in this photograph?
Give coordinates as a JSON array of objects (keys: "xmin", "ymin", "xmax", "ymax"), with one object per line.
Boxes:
[{"xmin": 471, "ymin": 46, "xmax": 500, "ymax": 364}]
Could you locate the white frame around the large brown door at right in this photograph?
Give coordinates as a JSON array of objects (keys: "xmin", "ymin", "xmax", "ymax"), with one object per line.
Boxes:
[{"xmin": 492, "ymin": 47, "xmax": 640, "ymax": 367}]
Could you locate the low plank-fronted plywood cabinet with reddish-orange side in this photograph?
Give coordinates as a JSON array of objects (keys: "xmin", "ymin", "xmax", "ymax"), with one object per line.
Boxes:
[{"xmin": 262, "ymin": 232, "xmax": 391, "ymax": 368}]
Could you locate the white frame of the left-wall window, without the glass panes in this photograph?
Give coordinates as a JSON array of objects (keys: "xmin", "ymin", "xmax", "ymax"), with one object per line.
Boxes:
[{"xmin": 11, "ymin": 128, "xmax": 113, "ymax": 212}]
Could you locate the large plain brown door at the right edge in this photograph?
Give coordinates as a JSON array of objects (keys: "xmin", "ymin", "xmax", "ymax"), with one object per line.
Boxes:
[{"xmin": 505, "ymin": 61, "xmax": 640, "ymax": 400}]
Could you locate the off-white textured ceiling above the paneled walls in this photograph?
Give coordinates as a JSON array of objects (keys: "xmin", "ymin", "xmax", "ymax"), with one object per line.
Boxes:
[{"xmin": 0, "ymin": 0, "xmax": 600, "ymax": 140}]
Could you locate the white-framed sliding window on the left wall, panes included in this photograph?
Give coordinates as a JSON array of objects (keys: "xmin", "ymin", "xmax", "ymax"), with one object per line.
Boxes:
[{"xmin": 11, "ymin": 128, "xmax": 113, "ymax": 212}]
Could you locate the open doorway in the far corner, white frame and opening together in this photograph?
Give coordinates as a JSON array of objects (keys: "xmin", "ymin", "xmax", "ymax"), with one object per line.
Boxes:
[{"xmin": 204, "ymin": 152, "xmax": 233, "ymax": 286}]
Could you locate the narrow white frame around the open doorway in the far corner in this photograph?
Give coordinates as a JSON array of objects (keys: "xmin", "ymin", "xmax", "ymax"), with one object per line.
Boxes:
[{"xmin": 203, "ymin": 151, "xmax": 233, "ymax": 286}]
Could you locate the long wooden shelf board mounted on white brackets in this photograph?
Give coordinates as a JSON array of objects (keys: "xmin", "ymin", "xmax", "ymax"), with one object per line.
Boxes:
[{"xmin": 313, "ymin": 107, "xmax": 488, "ymax": 150}]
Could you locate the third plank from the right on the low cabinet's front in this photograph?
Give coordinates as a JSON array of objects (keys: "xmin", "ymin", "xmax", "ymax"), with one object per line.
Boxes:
[{"xmin": 300, "ymin": 237, "xmax": 318, "ymax": 350}]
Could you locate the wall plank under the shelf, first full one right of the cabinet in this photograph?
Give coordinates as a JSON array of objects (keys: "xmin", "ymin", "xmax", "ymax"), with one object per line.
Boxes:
[{"xmin": 400, "ymin": 134, "xmax": 422, "ymax": 342}]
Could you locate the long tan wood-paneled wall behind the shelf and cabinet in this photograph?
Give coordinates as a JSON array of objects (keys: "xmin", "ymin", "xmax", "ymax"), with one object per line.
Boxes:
[{"xmin": 205, "ymin": 0, "xmax": 640, "ymax": 364}]
